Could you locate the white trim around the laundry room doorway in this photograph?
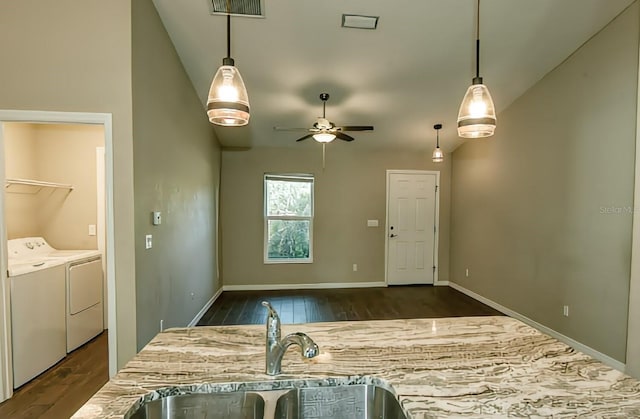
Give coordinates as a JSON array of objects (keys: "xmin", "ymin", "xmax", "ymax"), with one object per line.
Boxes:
[{"xmin": 0, "ymin": 110, "xmax": 118, "ymax": 401}]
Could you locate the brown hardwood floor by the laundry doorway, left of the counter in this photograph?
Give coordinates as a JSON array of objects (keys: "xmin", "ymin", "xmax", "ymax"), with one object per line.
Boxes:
[{"xmin": 0, "ymin": 331, "xmax": 109, "ymax": 419}]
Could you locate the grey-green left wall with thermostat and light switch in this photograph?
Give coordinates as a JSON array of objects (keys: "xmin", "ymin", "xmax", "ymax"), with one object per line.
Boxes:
[{"xmin": 131, "ymin": 0, "xmax": 220, "ymax": 349}]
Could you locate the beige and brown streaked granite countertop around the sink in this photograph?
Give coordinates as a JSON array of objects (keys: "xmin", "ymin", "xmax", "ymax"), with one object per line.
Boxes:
[{"xmin": 73, "ymin": 316, "xmax": 640, "ymax": 418}]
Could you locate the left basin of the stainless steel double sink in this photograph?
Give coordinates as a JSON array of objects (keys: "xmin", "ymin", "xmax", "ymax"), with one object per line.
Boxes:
[{"xmin": 126, "ymin": 392, "xmax": 264, "ymax": 419}]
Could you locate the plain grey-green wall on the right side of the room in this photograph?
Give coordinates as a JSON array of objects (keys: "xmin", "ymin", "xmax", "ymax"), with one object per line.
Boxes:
[{"xmin": 451, "ymin": 3, "xmax": 639, "ymax": 362}]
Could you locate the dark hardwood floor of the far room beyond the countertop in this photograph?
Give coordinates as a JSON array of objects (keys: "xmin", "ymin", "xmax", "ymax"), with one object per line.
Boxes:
[{"xmin": 198, "ymin": 285, "xmax": 502, "ymax": 326}]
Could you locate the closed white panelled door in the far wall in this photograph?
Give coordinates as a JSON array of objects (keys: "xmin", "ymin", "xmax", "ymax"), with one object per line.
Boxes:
[{"xmin": 387, "ymin": 171, "xmax": 438, "ymax": 285}]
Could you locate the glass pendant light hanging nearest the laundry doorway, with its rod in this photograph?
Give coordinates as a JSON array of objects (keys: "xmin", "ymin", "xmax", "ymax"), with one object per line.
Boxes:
[{"xmin": 207, "ymin": 0, "xmax": 249, "ymax": 127}]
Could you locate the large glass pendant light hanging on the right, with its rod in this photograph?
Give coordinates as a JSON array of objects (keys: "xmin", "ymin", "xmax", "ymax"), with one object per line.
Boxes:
[{"xmin": 458, "ymin": 0, "xmax": 496, "ymax": 138}]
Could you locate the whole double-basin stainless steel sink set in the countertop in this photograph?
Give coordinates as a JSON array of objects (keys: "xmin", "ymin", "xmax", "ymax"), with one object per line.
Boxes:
[{"xmin": 125, "ymin": 380, "xmax": 408, "ymax": 419}]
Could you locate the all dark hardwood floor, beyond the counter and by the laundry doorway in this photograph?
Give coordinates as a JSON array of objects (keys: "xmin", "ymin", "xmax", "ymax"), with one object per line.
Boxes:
[{"xmin": 0, "ymin": 286, "xmax": 502, "ymax": 419}]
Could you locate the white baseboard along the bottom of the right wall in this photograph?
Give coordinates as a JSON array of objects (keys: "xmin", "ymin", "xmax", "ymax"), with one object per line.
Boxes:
[{"xmin": 449, "ymin": 282, "xmax": 626, "ymax": 372}]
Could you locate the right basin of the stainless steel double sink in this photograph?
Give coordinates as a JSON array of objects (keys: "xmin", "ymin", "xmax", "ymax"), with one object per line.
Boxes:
[{"xmin": 274, "ymin": 384, "xmax": 407, "ymax": 419}]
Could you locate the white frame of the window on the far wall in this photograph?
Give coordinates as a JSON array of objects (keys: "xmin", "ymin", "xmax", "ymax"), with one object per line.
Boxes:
[{"xmin": 262, "ymin": 173, "xmax": 315, "ymax": 265}]
